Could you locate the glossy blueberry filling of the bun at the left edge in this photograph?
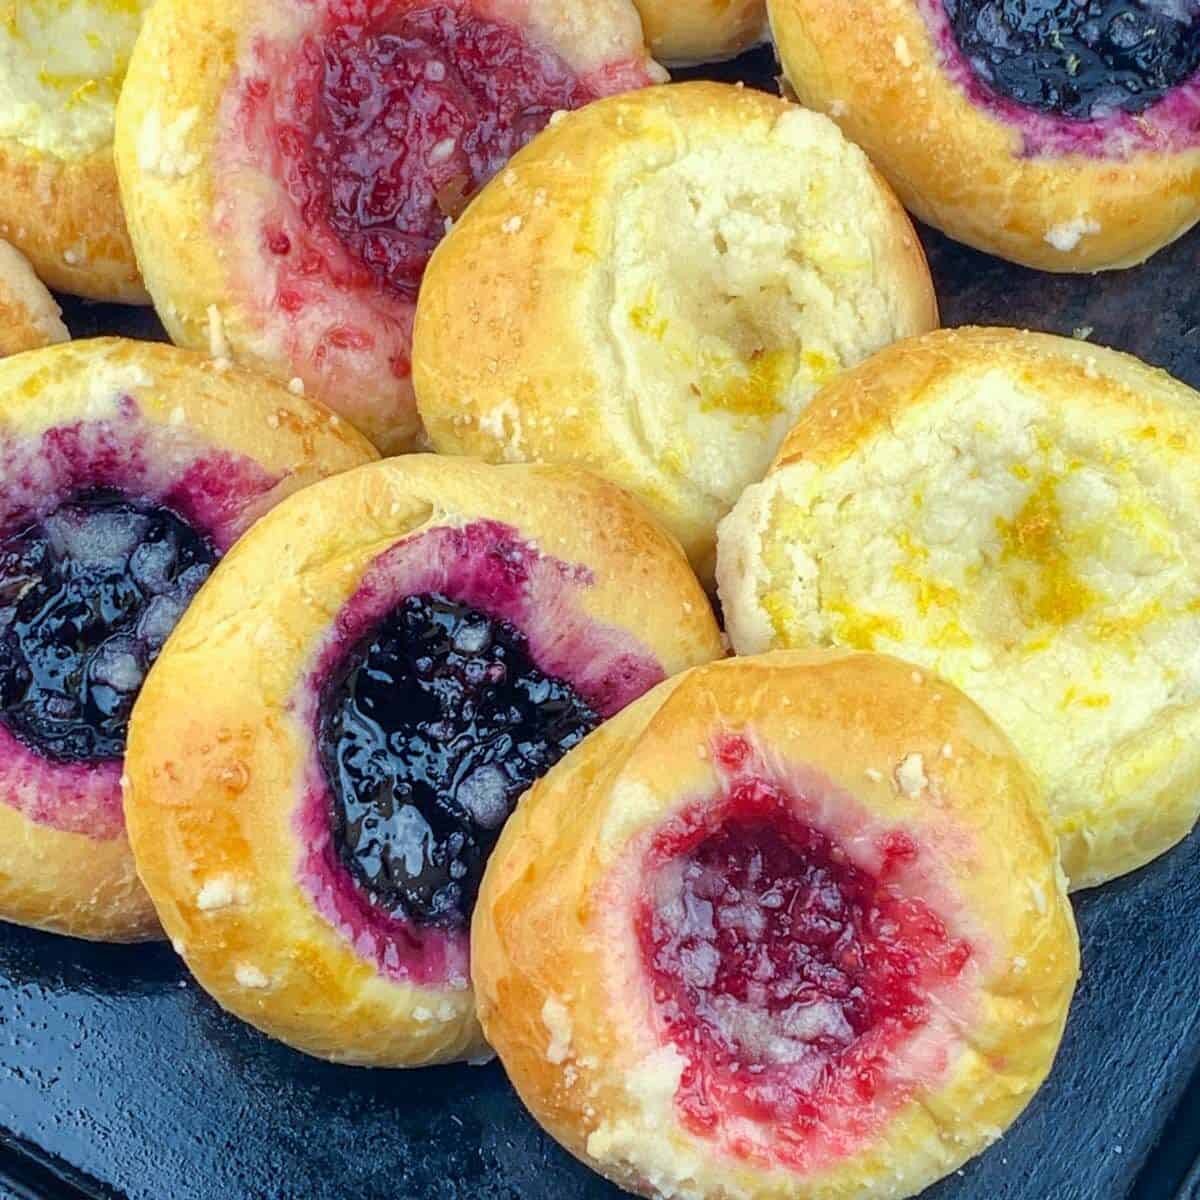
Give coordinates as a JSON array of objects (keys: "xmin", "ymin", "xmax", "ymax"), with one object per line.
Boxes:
[{"xmin": 0, "ymin": 491, "xmax": 217, "ymax": 762}]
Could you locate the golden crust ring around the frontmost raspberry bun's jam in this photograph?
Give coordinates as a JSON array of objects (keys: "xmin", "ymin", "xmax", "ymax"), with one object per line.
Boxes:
[{"xmin": 472, "ymin": 653, "xmax": 1079, "ymax": 1200}]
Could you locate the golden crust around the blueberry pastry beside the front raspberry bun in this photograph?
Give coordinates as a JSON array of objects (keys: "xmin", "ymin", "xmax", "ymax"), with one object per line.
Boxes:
[{"xmin": 126, "ymin": 455, "xmax": 722, "ymax": 1066}]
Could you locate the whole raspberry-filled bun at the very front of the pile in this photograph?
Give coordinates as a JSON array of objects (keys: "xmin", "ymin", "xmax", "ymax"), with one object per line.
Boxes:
[{"xmin": 472, "ymin": 653, "xmax": 1079, "ymax": 1200}]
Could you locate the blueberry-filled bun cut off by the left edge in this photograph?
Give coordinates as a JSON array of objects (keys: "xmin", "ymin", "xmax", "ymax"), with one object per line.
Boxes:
[{"xmin": 0, "ymin": 338, "xmax": 372, "ymax": 942}]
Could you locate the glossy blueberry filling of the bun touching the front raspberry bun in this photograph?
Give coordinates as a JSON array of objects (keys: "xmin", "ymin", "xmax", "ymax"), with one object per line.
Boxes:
[{"xmin": 319, "ymin": 594, "xmax": 600, "ymax": 928}]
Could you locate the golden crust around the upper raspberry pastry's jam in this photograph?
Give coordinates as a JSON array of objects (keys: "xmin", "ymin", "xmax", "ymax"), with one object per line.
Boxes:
[{"xmin": 116, "ymin": 0, "xmax": 664, "ymax": 454}]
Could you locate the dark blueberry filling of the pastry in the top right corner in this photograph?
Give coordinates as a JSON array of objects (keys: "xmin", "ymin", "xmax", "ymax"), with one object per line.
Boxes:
[{"xmin": 944, "ymin": 0, "xmax": 1200, "ymax": 120}]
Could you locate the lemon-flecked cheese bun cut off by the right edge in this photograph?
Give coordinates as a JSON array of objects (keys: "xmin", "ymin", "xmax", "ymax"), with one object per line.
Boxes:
[{"xmin": 718, "ymin": 329, "xmax": 1200, "ymax": 888}]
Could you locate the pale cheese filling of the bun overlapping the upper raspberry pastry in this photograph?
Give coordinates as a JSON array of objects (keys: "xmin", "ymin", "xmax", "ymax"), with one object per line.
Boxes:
[{"xmin": 609, "ymin": 135, "xmax": 898, "ymax": 512}]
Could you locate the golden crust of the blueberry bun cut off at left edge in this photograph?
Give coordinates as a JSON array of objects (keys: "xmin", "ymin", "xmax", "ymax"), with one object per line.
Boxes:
[{"xmin": 0, "ymin": 338, "xmax": 374, "ymax": 942}]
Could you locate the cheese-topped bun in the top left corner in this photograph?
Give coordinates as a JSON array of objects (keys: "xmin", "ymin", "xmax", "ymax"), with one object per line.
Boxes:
[{"xmin": 0, "ymin": 0, "xmax": 151, "ymax": 304}]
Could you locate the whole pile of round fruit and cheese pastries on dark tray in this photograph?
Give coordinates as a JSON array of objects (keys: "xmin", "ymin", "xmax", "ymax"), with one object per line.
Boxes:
[{"xmin": 0, "ymin": 0, "xmax": 1200, "ymax": 1200}]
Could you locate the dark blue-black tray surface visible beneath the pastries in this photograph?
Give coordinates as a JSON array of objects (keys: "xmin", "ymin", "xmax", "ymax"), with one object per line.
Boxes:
[{"xmin": 0, "ymin": 42, "xmax": 1200, "ymax": 1200}]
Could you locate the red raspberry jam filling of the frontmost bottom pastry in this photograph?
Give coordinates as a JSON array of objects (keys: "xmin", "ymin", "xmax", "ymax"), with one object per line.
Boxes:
[{"xmin": 636, "ymin": 778, "xmax": 972, "ymax": 1162}]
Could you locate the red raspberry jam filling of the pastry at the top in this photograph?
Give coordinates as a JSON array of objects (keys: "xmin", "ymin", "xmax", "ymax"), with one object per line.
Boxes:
[{"xmin": 297, "ymin": 0, "xmax": 592, "ymax": 299}]
